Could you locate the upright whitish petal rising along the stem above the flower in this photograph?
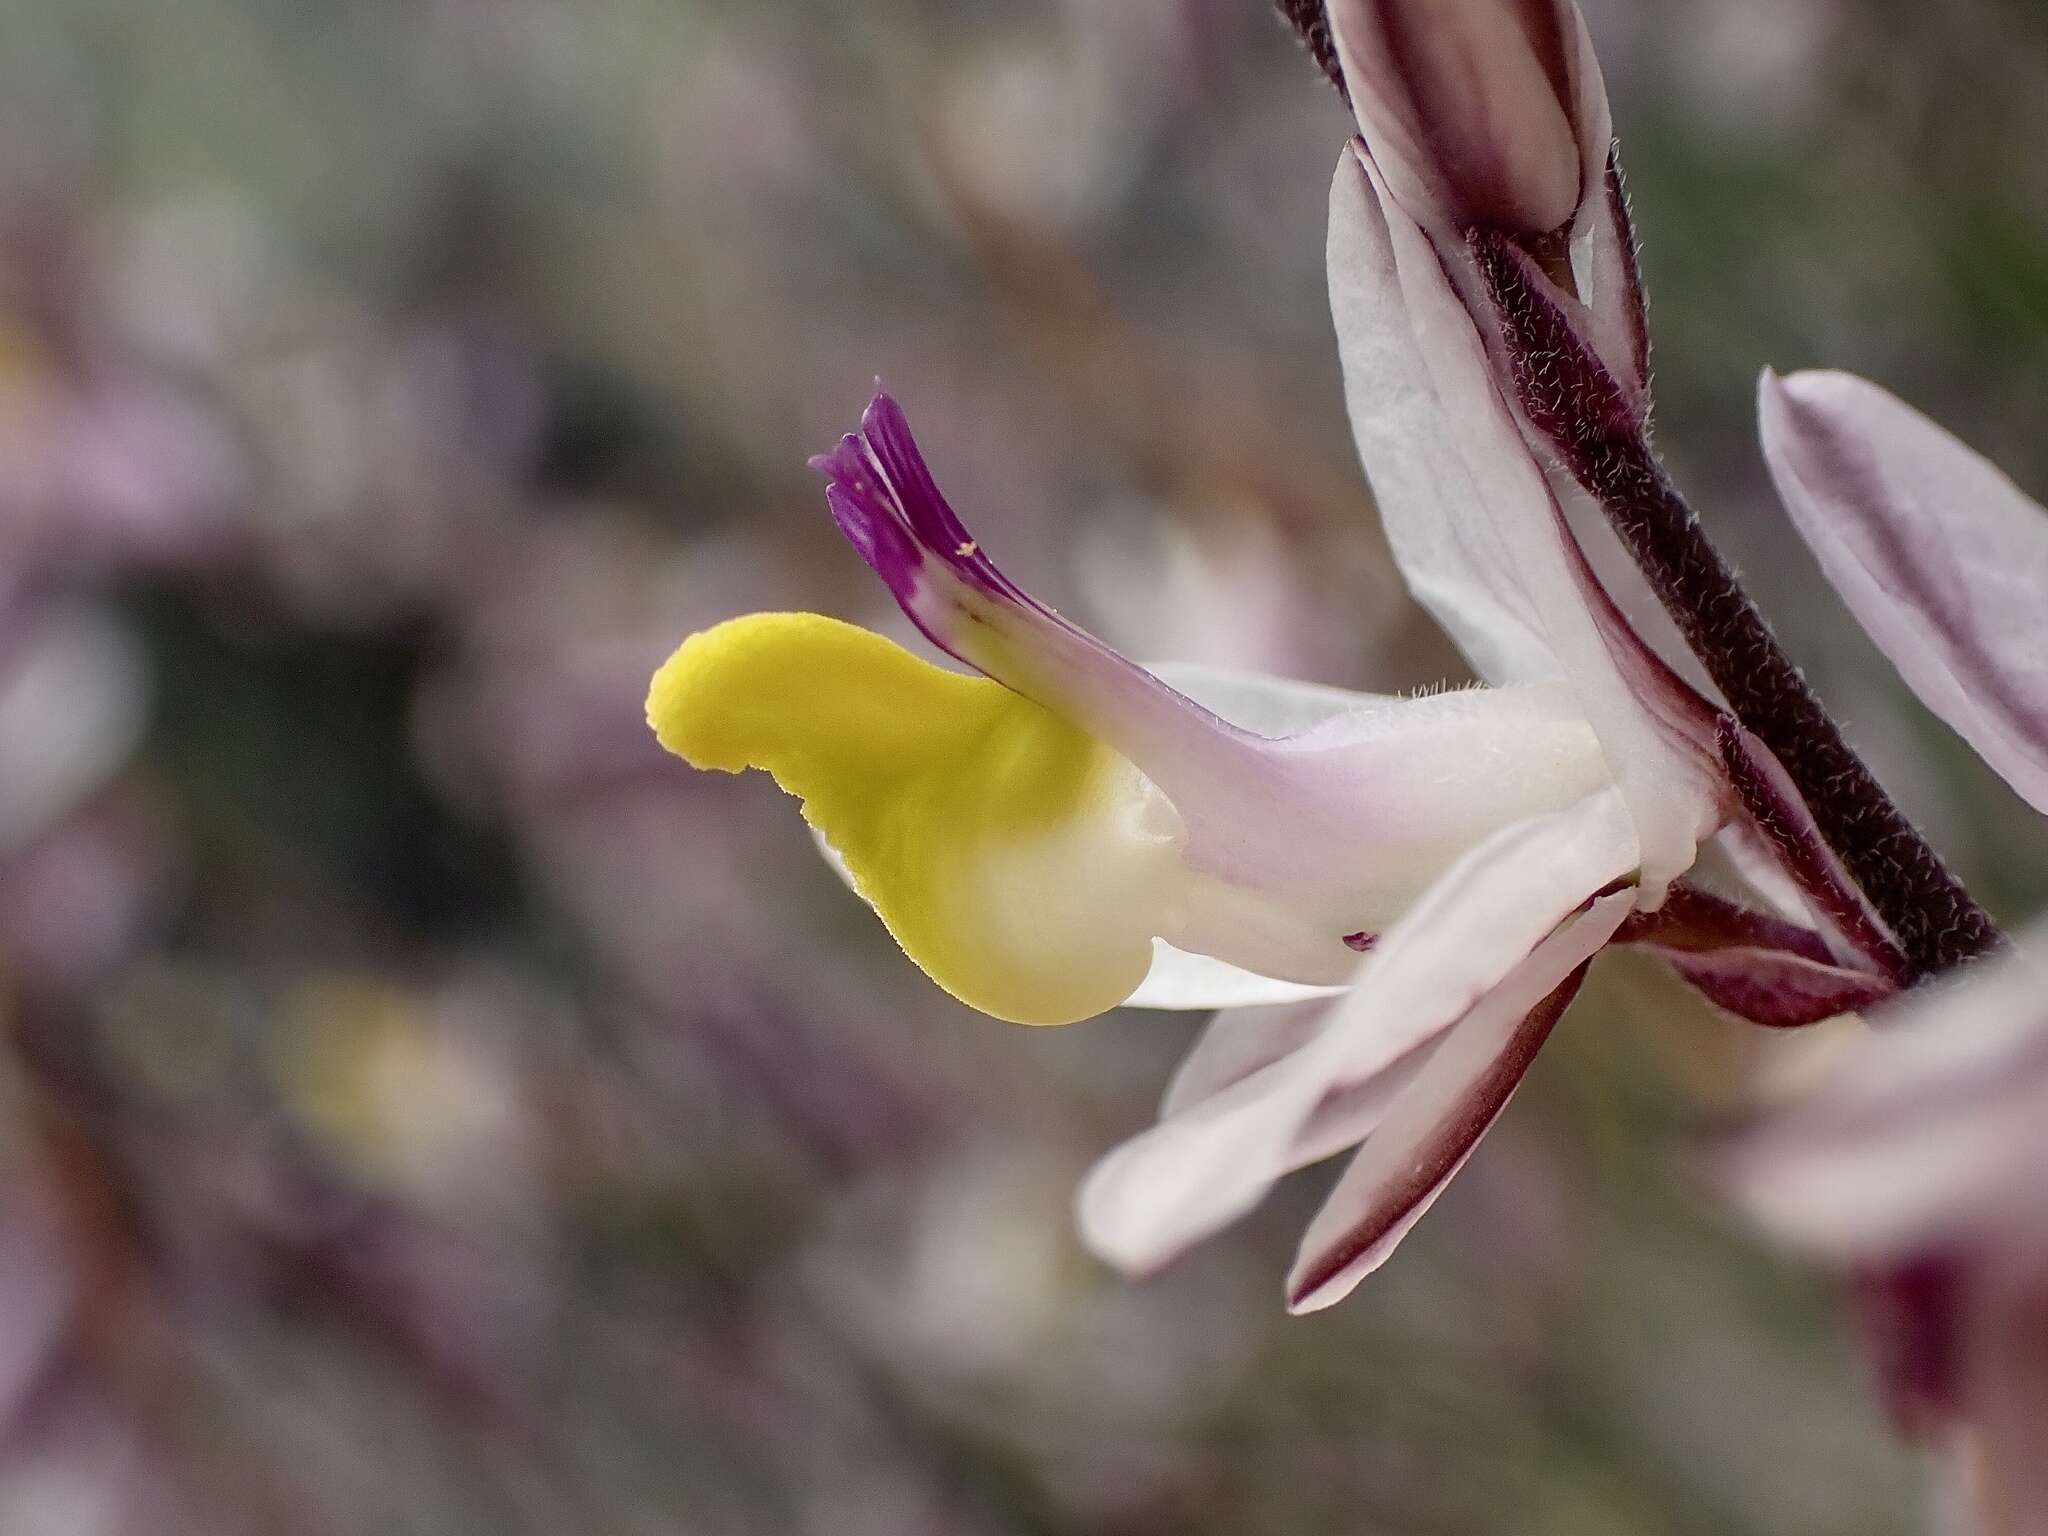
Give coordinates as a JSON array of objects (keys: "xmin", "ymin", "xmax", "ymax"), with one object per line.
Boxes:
[{"xmin": 1329, "ymin": 141, "xmax": 1720, "ymax": 903}]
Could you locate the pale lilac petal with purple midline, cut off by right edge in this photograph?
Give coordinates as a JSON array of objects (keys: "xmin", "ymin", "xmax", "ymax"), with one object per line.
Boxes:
[{"xmin": 1761, "ymin": 373, "xmax": 2048, "ymax": 811}]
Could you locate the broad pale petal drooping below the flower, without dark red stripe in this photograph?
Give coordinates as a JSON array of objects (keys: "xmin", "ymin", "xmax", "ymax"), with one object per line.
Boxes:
[{"xmin": 1079, "ymin": 788, "xmax": 1636, "ymax": 1272}]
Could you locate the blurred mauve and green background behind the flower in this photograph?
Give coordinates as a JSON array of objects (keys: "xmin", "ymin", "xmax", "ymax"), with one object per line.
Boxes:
[{"xmin": 0, "ymin": 0, "xmax": 2048, "ymax": 1536}]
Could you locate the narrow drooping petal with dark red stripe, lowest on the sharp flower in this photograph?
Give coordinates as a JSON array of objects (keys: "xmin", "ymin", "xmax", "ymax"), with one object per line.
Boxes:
[{"xmin": 1286, "ymin": 891, "xmax": 1632, "ymax": 1313}]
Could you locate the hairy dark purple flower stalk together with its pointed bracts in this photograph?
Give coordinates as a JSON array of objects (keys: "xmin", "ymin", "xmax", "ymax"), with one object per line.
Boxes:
[{"xmin": 1278, "ymin": 0, "xmax": 2001, "ymax": 985}]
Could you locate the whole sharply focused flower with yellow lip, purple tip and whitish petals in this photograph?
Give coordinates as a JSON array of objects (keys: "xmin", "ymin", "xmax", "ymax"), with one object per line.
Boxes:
[{"xmin": 649, "ymin": 387, "xmax": 1867, "ymax": 1309}]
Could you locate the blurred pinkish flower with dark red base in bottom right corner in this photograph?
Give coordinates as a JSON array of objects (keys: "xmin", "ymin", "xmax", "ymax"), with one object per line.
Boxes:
[{"xmin": 1729, "ymin": 928, "xmax": 2048, "ymax": 1536}]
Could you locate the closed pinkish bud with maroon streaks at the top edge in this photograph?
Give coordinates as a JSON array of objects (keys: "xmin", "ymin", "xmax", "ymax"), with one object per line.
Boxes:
[{"xmin": 1327, "ymin": 0, "xmax": 1608, "ymax": 236}]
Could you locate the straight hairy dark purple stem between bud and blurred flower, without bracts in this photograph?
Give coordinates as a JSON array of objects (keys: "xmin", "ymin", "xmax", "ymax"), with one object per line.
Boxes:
[{"xmin": 1470, "ymin": 233, "xmax": 2001, "ymax": 979}]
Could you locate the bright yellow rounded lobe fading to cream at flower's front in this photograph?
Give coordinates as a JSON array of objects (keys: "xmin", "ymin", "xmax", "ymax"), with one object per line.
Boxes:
[{"xmin": 647, "ymin": 612, "xmax": 1178, "ymax": 1024}]
